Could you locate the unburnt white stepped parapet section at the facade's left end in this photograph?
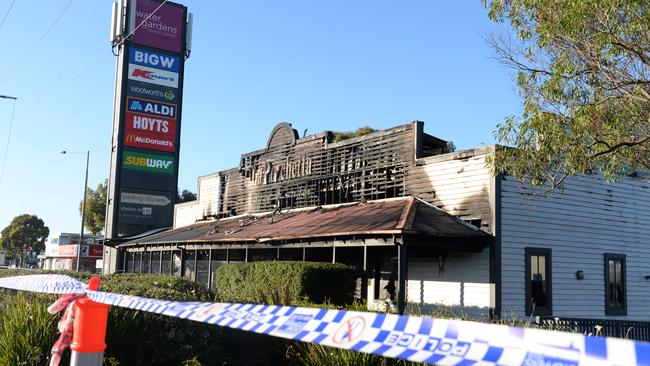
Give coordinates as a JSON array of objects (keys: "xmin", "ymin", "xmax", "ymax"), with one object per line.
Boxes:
[{"xmin": 174, "ymin": 173, "xmax": 221, "ymax": 228}]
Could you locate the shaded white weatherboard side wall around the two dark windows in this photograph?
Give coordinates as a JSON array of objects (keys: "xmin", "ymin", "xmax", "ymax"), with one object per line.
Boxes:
[{"xmin": 501, "ymin": 175, "xmax": 650, "ymax": 320}]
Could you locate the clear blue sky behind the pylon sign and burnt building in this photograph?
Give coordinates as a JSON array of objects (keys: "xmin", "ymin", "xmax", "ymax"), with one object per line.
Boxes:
[{"xmin": 0, "ymin": 0, "xmax": 521, "ymax": 239}]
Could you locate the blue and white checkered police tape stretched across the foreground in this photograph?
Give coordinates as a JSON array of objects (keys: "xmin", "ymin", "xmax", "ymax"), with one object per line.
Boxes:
[{"xmin": 0, "ymin": 275, "xmax": 650, "ymax": 366}]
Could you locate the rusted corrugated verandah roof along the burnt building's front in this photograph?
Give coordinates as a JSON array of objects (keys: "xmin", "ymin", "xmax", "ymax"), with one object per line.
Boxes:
[{"xmin": 121, "ymin": 197, "xmax": 490, "ymax": 246}]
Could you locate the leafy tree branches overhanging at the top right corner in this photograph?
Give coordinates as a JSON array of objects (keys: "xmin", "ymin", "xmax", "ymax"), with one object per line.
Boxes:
[{"xmin": 483, "ymin": 0, "xmax": 650, "ymax": 188}]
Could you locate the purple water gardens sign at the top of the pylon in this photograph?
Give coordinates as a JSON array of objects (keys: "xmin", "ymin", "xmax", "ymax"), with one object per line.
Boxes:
[{"xmin": 133, "ymin": 0, "xmax": 185, "ymax": 52}]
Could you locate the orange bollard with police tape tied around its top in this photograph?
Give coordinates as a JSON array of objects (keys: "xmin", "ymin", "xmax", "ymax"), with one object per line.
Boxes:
[{"xmin": 70, "ymin": 277, "xmax": 109, "ymax": 366}]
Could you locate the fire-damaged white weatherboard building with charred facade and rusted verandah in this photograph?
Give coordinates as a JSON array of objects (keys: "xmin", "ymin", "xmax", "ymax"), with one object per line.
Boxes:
[{"xmin": 104, "ymin": 122, "xmax": 650, "ymax": 319}]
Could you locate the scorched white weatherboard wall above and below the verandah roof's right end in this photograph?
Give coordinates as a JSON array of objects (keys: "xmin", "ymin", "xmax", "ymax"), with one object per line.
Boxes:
[{"xmin": 407, "ymin": 147, "xmax": 494, "ymax": 318}]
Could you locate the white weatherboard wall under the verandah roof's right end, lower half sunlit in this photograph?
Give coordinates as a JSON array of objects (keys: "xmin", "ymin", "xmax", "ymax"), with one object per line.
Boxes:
[{"xmin": 406, "ymin": 248, "xmax": 494, "ymax": 318}]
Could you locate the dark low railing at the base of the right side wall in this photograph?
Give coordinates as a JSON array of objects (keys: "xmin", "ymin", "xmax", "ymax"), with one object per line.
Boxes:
[{"xmin": 531, "ymin": 318, "xmax": 650, "ymax": 342}]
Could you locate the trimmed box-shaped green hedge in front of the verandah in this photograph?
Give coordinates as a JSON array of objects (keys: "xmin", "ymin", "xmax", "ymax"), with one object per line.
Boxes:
[{"xmin": 216, "ymin": 261, "xmax": 359, "ymax": 305}]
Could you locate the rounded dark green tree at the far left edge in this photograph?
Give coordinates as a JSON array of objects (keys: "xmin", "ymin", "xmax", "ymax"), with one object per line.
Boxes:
[{"xmin": 0, "ymin": 214, "xmax": 50, "ymax": 265}]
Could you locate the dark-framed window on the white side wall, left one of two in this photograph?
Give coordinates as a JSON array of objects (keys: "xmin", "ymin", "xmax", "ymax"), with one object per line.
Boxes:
[{"xmin": 526, "ymin": 248, "xmax": 553, "ymax": 315}]
